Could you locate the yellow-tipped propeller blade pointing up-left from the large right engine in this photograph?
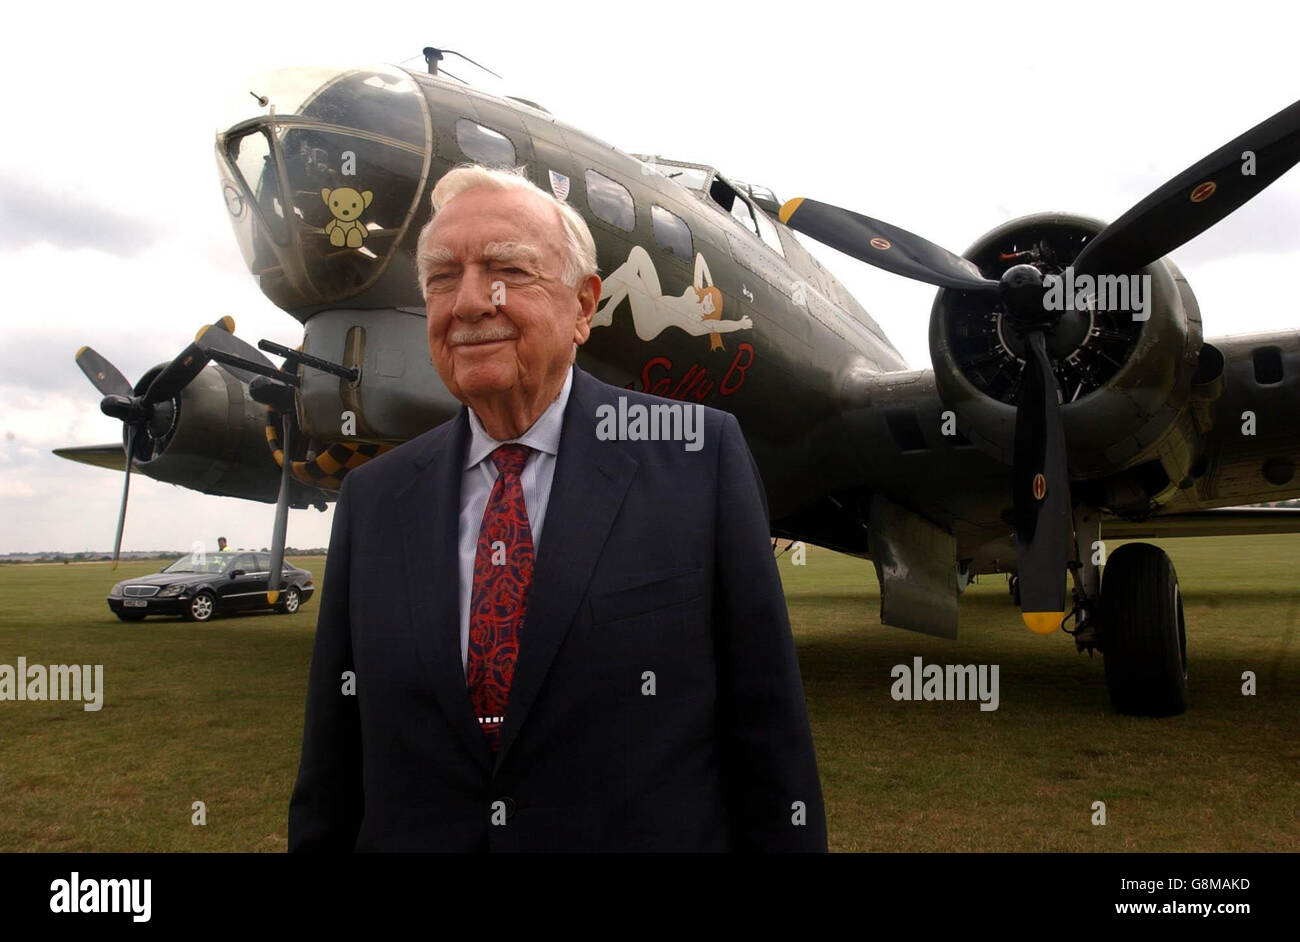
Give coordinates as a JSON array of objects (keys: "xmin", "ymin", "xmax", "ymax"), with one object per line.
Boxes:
[{"xmin": 779, "ymin": 197, "xmax": 998, "ymax": 292}]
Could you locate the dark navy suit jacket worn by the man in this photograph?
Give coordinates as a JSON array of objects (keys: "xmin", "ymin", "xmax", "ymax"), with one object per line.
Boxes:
[{"xmin": 289, "ymin": 368, "xmax": 827, "ymax": 851}]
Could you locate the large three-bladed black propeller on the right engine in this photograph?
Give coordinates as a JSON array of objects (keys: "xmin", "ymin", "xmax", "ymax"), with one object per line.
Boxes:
[{"xmin": 779, "ymin": 101, "xmax": 1300, "ymax": 634}]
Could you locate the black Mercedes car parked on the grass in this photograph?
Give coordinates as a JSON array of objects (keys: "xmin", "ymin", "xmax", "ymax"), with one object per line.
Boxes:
[{"xmin": 108, "ymin": 552, "xmax": 316, "ymax": 621}]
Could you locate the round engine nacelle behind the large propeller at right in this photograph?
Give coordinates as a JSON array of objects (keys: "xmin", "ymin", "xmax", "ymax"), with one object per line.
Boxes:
[{"xmin": 930, "ymin": 213, "xmax": 1216, "ymax": 505}]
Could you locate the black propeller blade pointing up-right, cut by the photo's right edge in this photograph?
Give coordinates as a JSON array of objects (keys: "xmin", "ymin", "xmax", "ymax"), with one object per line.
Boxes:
[{"xmin": 1074, "ymin": 101, "xmax": 1300, "ymax": 274}]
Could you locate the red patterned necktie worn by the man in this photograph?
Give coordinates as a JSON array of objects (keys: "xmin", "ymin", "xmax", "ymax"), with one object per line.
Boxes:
[{"xmin": 465, "ymin": 444, "xmax": 533, "ymax": 752}]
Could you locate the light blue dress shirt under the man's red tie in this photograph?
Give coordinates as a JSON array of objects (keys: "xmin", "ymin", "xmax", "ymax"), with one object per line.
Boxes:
[{"xmin": 460, "ymin": 366, "xmax": 573, "ymax": 670}]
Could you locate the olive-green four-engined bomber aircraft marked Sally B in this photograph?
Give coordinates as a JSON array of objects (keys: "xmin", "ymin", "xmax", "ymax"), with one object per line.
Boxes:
[{"xmin": 57, "ymin": 48, "xmax": 1300, "ymax": 716}]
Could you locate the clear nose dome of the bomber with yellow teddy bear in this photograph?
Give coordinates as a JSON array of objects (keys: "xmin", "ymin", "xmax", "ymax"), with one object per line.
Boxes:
[{"xmin": 217, "ymin": 66, "xmax": 433, "ymax": 312}]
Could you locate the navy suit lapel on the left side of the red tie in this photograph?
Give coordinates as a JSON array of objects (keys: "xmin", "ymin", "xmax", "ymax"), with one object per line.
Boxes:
[{"xmin": 397, "ymin": 408, "xmax": 491, "ymax": 770}]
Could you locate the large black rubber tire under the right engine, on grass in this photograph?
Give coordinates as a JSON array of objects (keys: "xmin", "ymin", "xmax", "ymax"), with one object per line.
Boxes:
[{"xmin": 1100, "ymin": 543, "xmax": 1190, "ymax": 716}]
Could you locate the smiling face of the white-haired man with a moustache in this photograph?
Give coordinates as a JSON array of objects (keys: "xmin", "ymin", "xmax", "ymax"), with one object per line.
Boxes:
[{"xmin": 421, "ymin": 187, "xmax": 601, "ymax": 405}]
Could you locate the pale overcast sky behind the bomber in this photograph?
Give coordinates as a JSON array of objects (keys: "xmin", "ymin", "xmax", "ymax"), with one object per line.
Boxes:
[{"xmin": 0, "ymin": 0, "xmax": 1300, "ymax": 552}]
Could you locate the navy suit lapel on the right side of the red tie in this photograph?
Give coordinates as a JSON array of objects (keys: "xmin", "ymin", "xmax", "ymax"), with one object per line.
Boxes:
[{"xmin": 493, "ymin": 366, "xmax": 637, "ymax": 768}]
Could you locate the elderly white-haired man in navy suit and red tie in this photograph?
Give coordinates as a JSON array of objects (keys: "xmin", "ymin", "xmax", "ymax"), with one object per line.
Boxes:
[{"xmin": 289, "ymin": 166, "xmax": 826, "ymax": 851}]
